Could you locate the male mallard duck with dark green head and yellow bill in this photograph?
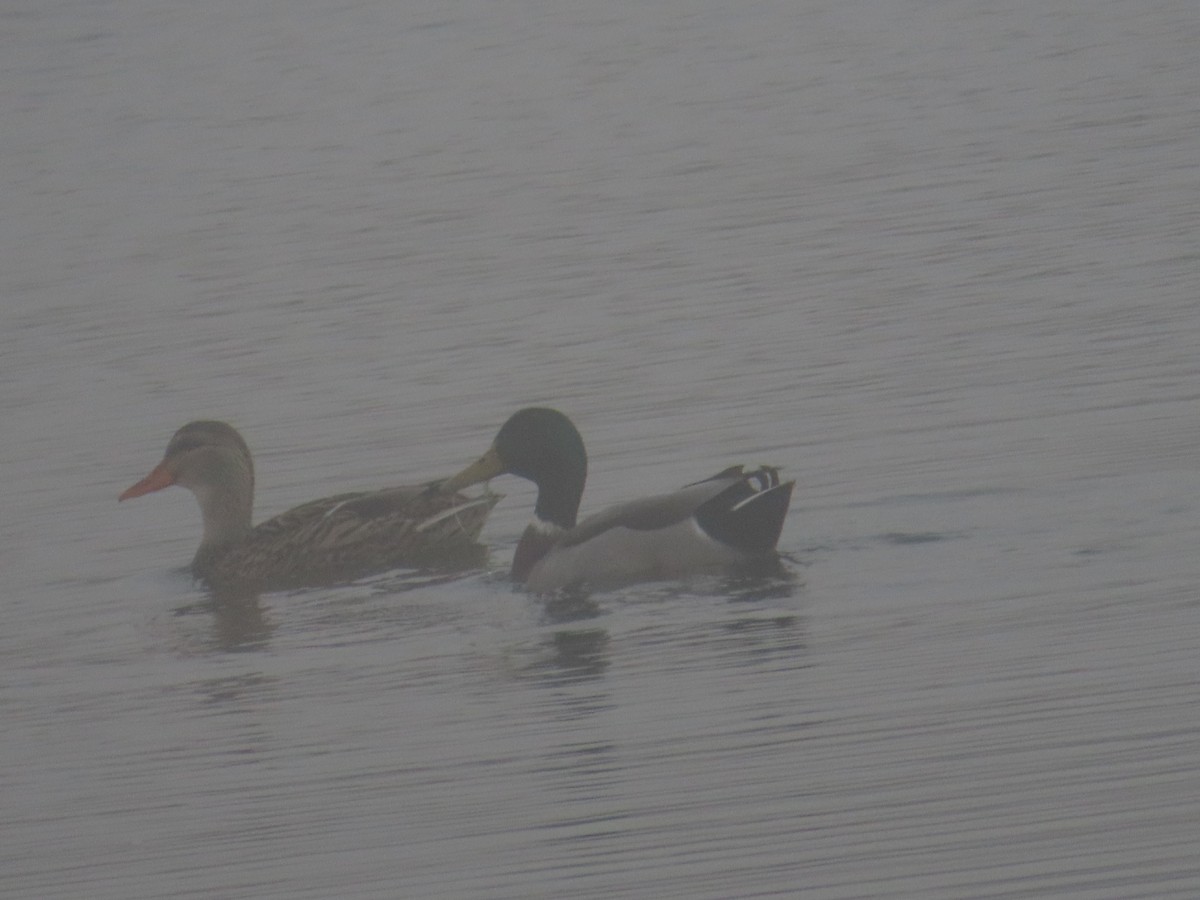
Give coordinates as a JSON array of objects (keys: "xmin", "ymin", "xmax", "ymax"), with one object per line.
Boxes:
[{"xmin": 440, "ymin": 407, "xmax": 794, "ymax": 593}]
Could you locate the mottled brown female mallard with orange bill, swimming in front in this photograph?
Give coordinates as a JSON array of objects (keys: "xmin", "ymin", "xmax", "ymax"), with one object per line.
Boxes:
[{"xmin": 119, "ymin": 421, "xmax": 499, "ymax": 590}]
